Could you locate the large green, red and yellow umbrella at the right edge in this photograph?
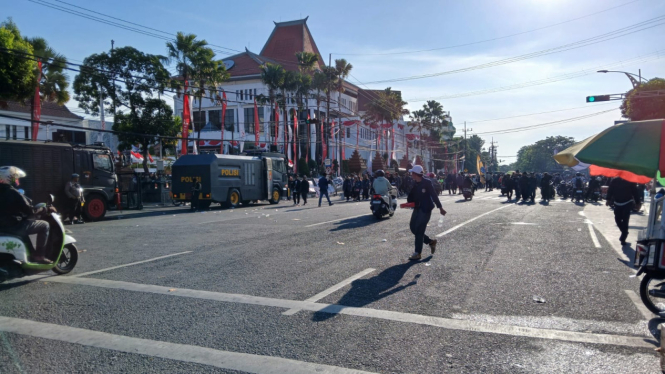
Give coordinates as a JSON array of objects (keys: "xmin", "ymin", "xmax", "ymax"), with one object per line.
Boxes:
[{"xmin": 554, "ymin": 119, "xmax": 665, "ymax": 183}]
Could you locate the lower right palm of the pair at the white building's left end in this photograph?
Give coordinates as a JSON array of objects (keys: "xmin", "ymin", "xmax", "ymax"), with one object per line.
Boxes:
[{"xmin": 192, "ymin": 48, "xmax": 229, "ymax": 144}]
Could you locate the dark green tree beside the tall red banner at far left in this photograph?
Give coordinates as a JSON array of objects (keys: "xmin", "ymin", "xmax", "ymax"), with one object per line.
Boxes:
[{"xmin": 25, "ymin": 38, "xmax": 69, "ymax": 139}]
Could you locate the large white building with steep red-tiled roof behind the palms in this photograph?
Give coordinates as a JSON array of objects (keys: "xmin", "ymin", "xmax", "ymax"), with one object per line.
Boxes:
[{"xmin": 174, "ymin": 18, "xmax": 420, "ymax": 170}]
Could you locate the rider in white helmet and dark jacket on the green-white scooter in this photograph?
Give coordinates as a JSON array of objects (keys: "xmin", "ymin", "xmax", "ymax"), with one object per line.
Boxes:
[{"xmin": 0, "ymin": 166, "xmax": 56, "ymax": 264}]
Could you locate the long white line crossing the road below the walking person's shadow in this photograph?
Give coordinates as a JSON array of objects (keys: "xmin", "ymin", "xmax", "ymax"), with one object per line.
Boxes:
[{"xmin": 40, "ymin": 277, "xmax": 656, "ymax": 348}]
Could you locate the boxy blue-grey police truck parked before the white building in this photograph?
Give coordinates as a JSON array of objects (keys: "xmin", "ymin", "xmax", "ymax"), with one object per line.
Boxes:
[{"xmin": 171, "ymin": 153, "xmax": 288, "ymax": 209}]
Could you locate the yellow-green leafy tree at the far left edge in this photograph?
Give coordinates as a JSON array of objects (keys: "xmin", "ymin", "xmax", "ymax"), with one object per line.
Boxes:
[{"xmin": 0, "ymin": 19, "xmax": 37, "ymax": 108}]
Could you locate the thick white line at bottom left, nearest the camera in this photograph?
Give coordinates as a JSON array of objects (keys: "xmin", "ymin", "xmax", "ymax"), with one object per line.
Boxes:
[{"xmin": 0, "ymin": 317, "xmax": 374, "ymax": 374}]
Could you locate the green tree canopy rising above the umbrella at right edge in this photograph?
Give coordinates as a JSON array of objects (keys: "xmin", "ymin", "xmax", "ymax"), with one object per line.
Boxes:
[{"xmin": 621, "ymin": 78, "xmax": 665, "ymax": 121}]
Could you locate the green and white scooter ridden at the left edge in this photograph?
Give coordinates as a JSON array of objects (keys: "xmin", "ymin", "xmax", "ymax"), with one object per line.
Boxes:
[{"xmin": 0, "ymin": 195, "xmax": 78, "ymax": 283}]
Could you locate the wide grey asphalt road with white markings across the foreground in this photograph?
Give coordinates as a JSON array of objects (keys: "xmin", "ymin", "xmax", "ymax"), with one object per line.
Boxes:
[{"xmin": 0, "ymin": 191, "xmax": 659, "ymax": 373}]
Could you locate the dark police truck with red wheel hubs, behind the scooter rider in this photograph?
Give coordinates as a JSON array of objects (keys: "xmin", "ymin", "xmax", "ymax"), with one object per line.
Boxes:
[{"xmin": 0, "ymin": 140, "xmax": 118, "ymax": 221}]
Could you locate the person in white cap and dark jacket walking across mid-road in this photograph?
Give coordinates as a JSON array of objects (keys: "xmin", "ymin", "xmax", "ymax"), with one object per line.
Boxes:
[{"xmin": 406, "ymin": 165, "xmax": 446, "ymax": 261}]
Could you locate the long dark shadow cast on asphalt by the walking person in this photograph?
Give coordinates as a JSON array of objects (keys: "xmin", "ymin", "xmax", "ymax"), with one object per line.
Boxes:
[{"xmin": 312, "ymin": 256, "xmax": 432, "ymax": 322}]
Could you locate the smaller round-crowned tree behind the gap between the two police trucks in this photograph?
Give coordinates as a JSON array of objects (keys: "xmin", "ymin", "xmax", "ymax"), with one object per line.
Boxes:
[{"xmin": 113, "ymin": 98, "xmax": 180, "ymax": 174}]
